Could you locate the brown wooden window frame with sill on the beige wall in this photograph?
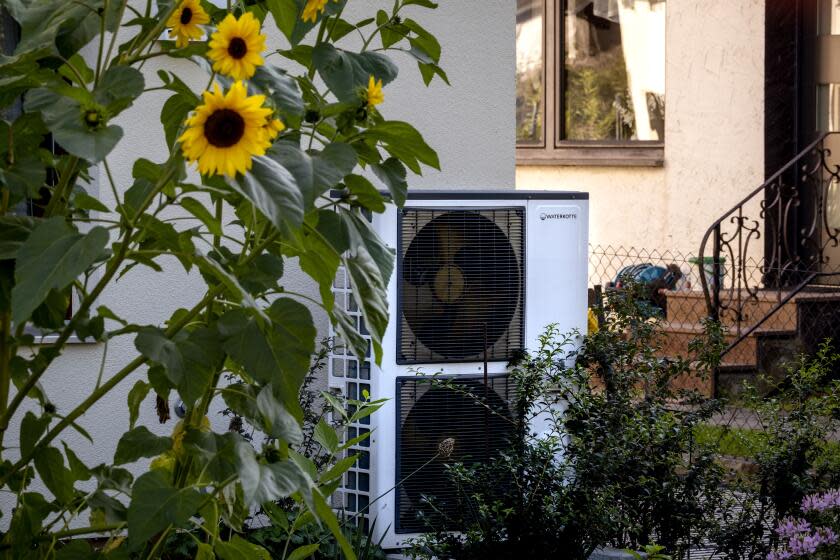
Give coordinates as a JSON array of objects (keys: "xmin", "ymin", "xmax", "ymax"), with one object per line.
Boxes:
[{"xmin": 516, "ymin": 0, "xmax": 667, "ymax": 167}]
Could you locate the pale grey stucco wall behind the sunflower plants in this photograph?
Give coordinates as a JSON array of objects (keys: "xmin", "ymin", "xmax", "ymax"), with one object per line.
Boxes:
[{"xmin": 0, "ymin": 0, "xmax": 515, "ymax": 492}]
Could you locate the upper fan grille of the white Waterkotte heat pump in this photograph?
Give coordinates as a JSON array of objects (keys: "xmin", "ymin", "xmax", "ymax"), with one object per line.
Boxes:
[{"xmin": 397, "ymin": 208, "xmax": 525, "ymax": 364}]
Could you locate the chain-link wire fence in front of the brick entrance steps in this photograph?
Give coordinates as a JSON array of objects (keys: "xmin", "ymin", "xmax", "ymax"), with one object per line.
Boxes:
[{"xmin": 589, "ymin": 246, "xmax": 840, "ymax": 560}]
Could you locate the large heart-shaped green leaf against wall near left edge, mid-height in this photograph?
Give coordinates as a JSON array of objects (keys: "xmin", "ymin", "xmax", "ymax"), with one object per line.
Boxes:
[{"xmin": 12, "ymin": 217, "xmax": 109, "ymax": 324}]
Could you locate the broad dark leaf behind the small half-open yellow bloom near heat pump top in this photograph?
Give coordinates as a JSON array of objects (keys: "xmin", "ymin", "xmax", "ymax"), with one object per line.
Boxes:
[{"xmin": 312, "ymin": 43, "xmax": 398, "ymax": 101}]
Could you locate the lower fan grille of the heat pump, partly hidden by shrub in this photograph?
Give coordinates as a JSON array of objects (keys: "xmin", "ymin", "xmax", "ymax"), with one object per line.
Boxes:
[{"xmin": 395, "ymin": 375, "xmax": 516, "ymax": 533}]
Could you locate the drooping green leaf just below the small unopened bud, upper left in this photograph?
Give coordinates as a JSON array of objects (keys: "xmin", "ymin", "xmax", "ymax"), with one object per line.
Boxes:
[{"xmin": 24, "ymin": 88, "xmax": 123, "ymax": 163}]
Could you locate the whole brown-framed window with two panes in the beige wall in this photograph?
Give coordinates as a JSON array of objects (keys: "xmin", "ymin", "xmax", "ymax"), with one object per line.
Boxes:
[{"xmin": 516, "ymin": 0, "xmax": 666, "ymax": 165}]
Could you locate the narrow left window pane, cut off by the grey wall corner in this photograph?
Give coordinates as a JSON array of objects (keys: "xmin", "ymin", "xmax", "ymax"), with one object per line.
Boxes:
[{"xmin": 516, "ymin": 0, "xmax": 543, "ymax": 144}]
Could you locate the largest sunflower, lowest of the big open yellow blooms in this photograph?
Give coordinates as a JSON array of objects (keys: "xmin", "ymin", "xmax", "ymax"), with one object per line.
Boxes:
[{"xmin": 178, "ymin": 82, "xmax": 272, "ymax": 177}]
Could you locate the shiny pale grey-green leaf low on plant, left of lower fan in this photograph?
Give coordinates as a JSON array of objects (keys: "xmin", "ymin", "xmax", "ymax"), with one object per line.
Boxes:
[{"xmin": 236, "ymin": 441, "xmax": 311, "ymax": 506}]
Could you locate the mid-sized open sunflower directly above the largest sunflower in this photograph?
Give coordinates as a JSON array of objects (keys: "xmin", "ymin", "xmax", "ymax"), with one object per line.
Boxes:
[{"xmin": 207, "ymin": 12, "xmax": 265, "ymax": 80}]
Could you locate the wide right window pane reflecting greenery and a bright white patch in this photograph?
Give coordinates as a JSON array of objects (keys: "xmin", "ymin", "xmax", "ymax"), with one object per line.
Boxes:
[{"xmin": 563, "ymin": 0, "xmax": 665, "ymax": 142}]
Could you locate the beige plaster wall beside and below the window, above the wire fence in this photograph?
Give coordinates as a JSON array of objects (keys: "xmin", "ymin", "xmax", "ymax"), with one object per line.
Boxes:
[{"xmin": 516, "ymin": 0, "xmax": 764, "ymax": 254}]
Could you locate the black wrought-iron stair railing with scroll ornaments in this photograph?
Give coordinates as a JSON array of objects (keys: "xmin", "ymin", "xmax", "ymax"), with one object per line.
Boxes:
[{"xmin": 698, "ymin": 132, "xmax": 840, "ymax": 352}]
